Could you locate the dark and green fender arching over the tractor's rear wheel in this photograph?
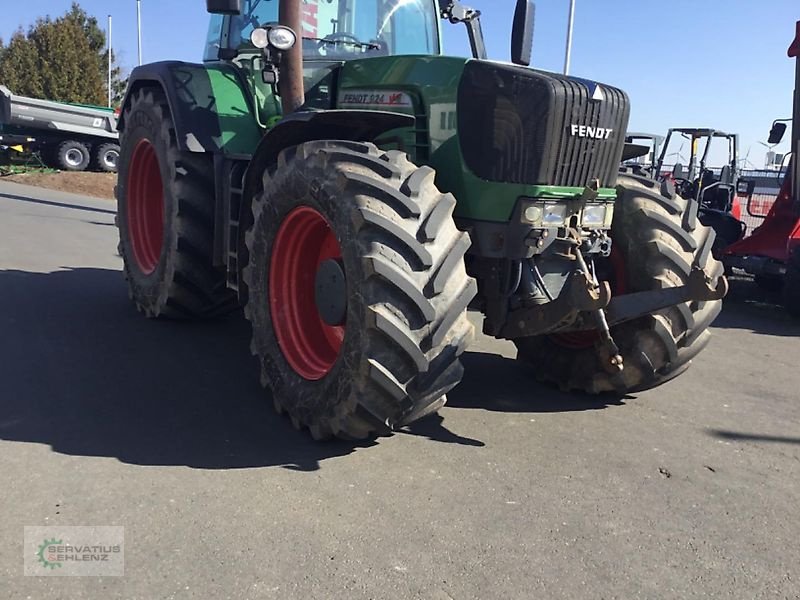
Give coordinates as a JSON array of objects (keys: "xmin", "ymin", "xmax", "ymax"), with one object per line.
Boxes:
[{"xmin": 117, "ymin": 61, "xmax": 262, "ymax": 155}]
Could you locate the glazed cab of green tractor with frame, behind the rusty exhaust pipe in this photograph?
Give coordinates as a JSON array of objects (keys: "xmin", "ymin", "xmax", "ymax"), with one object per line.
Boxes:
[{"xmin": 204, "ymin": 0, "xmax": 441, "ymax": 128}]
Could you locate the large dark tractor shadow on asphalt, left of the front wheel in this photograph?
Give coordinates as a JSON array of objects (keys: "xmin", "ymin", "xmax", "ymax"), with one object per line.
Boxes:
[{"xmin": 0, "ymin": 269, "xmax": 369, "ymax": 471}]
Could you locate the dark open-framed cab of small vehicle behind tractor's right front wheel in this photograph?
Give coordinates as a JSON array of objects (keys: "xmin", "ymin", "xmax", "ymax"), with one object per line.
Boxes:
[{"xmin": 656, "ymin": 128, "xmax": 739, "ymax": 212}]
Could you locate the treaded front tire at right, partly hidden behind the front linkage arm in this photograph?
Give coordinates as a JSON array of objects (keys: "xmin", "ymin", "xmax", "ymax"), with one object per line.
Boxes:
[{"xmin": 517, "ymin": 175, "xmax": 723, "ymax": 393}]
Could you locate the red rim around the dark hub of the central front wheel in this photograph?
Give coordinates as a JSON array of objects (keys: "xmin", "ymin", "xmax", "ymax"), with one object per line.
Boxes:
[{"xmin": 269, "ymin": 206, "xmax": 345, "ymax": 381}]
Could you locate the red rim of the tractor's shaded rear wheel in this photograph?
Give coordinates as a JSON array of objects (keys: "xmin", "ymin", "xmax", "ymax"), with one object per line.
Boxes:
[{"xmin": 127, "ymin": 140, "xmax": 164, "ymax": 275}]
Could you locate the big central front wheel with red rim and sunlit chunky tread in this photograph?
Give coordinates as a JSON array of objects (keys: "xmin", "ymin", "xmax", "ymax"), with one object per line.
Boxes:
[{"xmin": 243, "ymin": 141, "xmax": 477, "ymax": 439}]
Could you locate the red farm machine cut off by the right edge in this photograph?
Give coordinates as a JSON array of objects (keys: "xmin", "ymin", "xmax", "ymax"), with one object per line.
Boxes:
[{"xmin": 723, "ymin": 21, "xmax": 800, "ymax": 317}]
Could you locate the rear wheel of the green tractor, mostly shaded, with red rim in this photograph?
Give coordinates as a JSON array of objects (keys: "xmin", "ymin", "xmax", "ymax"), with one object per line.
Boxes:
[{"xmin": 117, "ymin": 88, "xmax": 236, "ymax": 319}]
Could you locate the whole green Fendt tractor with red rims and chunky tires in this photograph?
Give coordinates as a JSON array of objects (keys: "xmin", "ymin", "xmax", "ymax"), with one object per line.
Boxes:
[{"xmin": 117, "ymin": 0, "xmax": 727, "ymax": 439}]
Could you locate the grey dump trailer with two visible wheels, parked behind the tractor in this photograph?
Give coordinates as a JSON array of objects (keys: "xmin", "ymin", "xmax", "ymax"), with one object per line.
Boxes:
[{"xmin": 0, "ymin": 85, "xmax": 119, "ymax": 172}]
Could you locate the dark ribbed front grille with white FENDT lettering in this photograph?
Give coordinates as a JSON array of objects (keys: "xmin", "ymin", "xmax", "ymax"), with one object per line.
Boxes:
[{"xmin": 458, "ymin": 61, "xmax": 629, "ymax": 187}]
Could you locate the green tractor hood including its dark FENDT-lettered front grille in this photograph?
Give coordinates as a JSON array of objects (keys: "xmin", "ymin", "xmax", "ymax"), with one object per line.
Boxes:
[{"xmin": 334, "ymin": 56, "xmax": 630, "ymax": 187}]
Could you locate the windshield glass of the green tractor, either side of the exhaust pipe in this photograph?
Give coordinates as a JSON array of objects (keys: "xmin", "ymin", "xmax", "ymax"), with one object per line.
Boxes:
[{"xmin": 229, "ymin": 0, "xmax": 439, "ymax": 60}]
